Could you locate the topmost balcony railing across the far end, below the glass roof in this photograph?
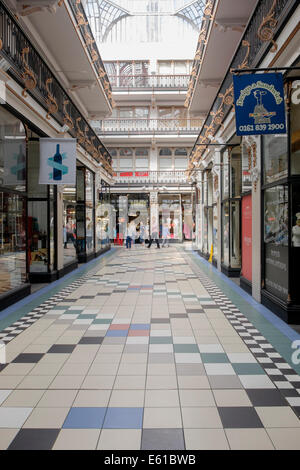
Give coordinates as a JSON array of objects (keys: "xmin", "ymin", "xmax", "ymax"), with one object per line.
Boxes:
[{"xmin": 109, "ymin": 75, "xmax": 190, "ymax": 91}]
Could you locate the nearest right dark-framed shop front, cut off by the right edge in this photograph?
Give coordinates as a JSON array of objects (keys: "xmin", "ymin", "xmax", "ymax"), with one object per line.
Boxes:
[{"xmin": 261, "ymin": 79, "xmax": 300, "ymax": 324}]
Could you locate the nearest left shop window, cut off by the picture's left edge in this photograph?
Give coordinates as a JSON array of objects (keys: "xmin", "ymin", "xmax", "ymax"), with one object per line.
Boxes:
[{"xmin": 0, "ymin": 107, "xmax": 30, "ymax": 309}]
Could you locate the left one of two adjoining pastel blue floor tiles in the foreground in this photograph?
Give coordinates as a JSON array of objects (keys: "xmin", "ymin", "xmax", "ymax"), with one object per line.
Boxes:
[{"xmin": 63, "ymin": 407, "xmax": 106, "ymax": 429}]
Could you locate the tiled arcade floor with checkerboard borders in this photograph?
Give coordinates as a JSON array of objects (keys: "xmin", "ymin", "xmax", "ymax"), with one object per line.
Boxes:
[{"xmin": 0, "ymin": 247, "xmax": 300, "ymax": 450}]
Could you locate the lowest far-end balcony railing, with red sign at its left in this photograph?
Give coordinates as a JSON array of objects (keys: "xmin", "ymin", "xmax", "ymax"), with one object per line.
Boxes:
[{"xmin": 114, "ymin": 170, "xmax": 190, "ymax": 186}]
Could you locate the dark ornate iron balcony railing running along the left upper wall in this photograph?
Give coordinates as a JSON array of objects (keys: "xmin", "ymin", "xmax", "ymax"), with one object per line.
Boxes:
[{"xmin": 0, "ymin": 3, "xmax": 111, "ymax": 172}]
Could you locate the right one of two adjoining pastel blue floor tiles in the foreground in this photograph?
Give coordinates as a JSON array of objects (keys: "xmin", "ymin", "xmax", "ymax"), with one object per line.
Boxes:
[{"xmin": 103, "ymin": 408, "xmax": 144, "ymax": 429}]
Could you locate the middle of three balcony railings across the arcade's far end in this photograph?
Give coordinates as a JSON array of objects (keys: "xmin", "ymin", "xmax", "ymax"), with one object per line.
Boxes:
[{"xmin": 93, "ymin": 118, "xmax": 202, "ymax": 135}]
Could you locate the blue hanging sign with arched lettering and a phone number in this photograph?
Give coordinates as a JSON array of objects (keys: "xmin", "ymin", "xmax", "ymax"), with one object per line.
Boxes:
[{"xmin": 233, "ymin": 73, "xmax": 286, "ymax": 135}]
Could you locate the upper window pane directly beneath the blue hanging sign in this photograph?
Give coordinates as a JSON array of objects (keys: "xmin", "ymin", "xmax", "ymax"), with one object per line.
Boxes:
[{"xmin": 263, "ymin": 135, "xmax": 288, "ymax": 184}]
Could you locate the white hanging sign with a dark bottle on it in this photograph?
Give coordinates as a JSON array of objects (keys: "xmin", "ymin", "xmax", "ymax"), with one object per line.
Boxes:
[{"xmin": 39, "ymin": 138, "xmax": 76, "ymax": 184}]
